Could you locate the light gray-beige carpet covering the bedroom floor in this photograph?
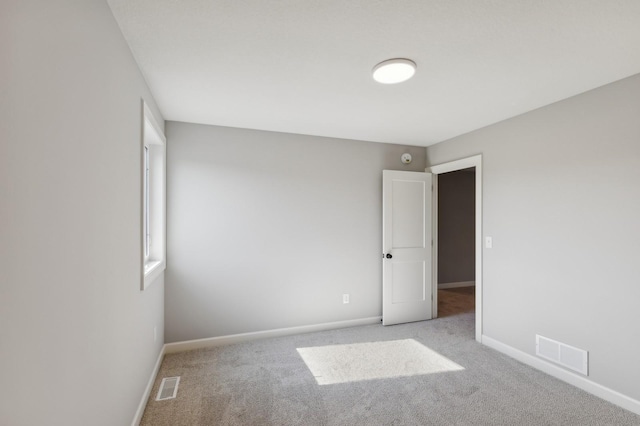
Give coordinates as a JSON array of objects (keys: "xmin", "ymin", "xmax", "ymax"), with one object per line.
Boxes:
[{"xmin": 142, "ymin": 298, "xmax": 640, "ymax": 426}]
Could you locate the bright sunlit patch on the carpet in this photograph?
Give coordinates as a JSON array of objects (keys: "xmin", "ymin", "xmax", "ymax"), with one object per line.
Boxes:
[{"xmin": 297, "ymin": 339, "xmax": 464, "ymax": 385}]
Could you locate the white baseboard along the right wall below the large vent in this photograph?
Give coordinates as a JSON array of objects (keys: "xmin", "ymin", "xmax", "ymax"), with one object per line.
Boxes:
[{"xmin": 482, "ymin": 335, "xmax": 640, "ymax": 415}]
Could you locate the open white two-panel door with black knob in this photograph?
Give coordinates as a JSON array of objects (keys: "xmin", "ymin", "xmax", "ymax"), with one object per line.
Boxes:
[{"xmin": 382, "ymin": 170, "xmax": 433, "ymax": 325}]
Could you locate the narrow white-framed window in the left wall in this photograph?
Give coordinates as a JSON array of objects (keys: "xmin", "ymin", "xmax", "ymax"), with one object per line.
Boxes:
[{"xmin": 141, "ymin": 102, "xmax": 166, "ymax": 290}]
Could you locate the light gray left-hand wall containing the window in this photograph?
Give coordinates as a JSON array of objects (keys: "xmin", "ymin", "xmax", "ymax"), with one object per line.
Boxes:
[{"xmin": 0, "ymin": 0, "xmax": 164, "ymax": 426}]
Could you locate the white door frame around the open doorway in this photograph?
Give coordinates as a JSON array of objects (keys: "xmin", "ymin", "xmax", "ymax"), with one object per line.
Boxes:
[{"xmin": 425, "ymin": 155, "xmax": 482, "ymax": 343}]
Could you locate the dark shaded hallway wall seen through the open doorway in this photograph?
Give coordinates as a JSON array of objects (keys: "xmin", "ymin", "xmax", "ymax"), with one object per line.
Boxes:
[{"xmin": 438, "ymin": 169, "xmax": 476, "ymax": 284}]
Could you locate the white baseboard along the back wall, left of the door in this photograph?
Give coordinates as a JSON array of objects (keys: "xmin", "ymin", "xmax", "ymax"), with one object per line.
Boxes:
[{"xmin": 164, "ymin": 317, "xmax": 382, "ymax": 354}]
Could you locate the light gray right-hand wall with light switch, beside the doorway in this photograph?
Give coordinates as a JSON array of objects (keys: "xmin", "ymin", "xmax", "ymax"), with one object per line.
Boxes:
[{"xmin": 427, "ymin": 75, "xmax": 640, "ymax": 400}]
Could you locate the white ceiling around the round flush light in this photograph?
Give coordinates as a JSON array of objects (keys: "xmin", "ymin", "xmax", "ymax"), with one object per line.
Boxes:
[{"xmin": 108, "ymin": 0, "xmax": 640, "ymax": 146}]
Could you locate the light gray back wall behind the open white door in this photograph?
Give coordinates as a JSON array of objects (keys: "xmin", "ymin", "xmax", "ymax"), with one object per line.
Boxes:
[{"xmin": 165, "ymin": 122, "xmax": 425, "ymax": 342}]
